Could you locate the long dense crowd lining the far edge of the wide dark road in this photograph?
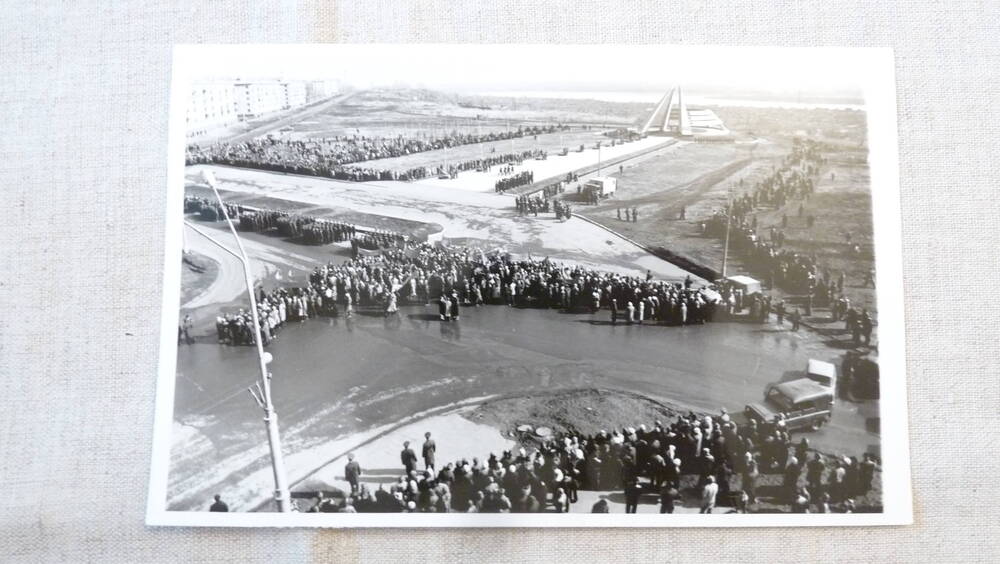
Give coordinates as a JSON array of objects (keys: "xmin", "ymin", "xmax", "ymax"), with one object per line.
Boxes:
[{"xmin": 213, "ymin": 240, "xmax": 720, "ymax": 344}]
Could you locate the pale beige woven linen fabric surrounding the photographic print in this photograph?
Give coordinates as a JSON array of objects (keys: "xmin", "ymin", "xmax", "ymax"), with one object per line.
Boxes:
[{"xmin": 0, "ymin": 0, "xmax": 1000, "ymax": 562}]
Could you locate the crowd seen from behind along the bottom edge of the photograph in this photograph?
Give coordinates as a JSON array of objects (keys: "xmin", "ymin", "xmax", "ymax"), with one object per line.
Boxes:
[{"xmin": 288, "ymin": 410, "xmax": 879, "ymax": 513}]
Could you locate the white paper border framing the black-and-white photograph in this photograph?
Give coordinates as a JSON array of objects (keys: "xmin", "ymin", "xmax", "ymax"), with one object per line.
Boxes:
[{"xmin": 146, "ymin": 44, "xmax": 913, "ymax": 528}]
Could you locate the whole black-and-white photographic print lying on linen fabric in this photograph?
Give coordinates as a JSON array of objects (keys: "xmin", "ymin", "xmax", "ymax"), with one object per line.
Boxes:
[{"xmin": 147, "ymin": 45, "xmax": 912, "ymax": 527}]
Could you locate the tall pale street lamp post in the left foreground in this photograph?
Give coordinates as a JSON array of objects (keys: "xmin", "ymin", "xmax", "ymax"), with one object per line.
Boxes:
[{"xmin": 184, "ymin": 174, "xmax": 291, "ymax": 513}]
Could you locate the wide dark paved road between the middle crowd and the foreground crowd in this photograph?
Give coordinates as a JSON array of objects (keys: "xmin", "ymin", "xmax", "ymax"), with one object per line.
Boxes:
[{"xmin": 170, "ymin": 306, "xmax": 879, "ymax": 509}]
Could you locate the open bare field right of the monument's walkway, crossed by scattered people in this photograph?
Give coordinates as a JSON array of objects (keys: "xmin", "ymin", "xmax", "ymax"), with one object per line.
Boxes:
[{"xmin": 576, "ymin": 108, "xmax": 877, "ymax": 323}]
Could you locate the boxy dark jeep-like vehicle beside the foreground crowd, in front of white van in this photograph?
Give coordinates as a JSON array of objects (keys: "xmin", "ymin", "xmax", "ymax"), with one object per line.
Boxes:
[{"xmin": 745, "ymin": 378, "xmax": 833, "ymax": 431}]
